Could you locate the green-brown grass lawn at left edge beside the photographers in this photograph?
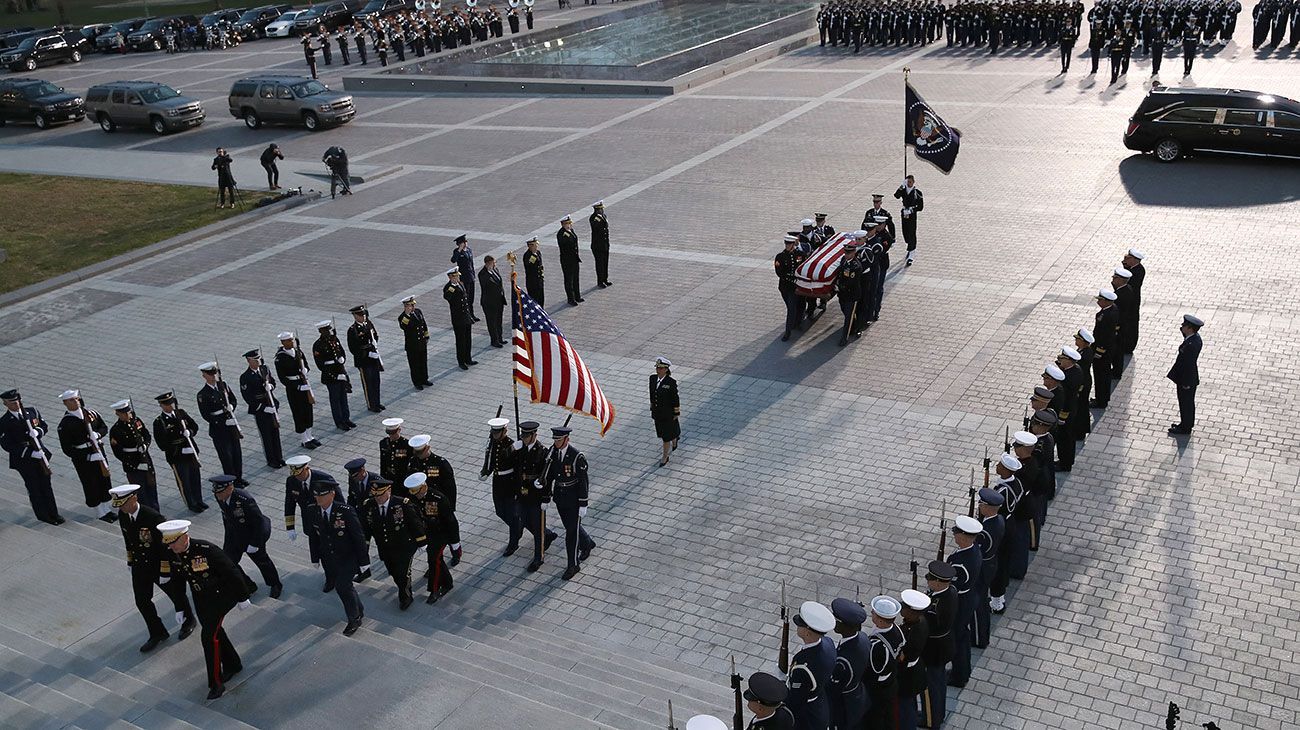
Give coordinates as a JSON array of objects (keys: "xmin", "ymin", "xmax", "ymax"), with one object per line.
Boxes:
[{"xmin": 0, "ymin": 173, "xmax": 239, "ymax": 292}]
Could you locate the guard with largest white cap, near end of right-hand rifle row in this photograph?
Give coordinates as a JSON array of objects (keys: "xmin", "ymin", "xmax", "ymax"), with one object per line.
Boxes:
[{"xmin": 785, "ymin": 600, "xmax": 836, "ymax": 730}]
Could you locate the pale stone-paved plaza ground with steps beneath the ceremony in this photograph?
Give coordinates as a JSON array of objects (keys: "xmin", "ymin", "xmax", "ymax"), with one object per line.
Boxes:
[{"xmin": 0, "ymin": 8, "xmax": 1300, "ymax": 730}]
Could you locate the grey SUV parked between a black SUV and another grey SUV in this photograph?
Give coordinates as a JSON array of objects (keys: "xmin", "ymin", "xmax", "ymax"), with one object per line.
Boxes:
[{"xmin": 86, "ymin": 81, "xmax": 205, "ymax": 134}]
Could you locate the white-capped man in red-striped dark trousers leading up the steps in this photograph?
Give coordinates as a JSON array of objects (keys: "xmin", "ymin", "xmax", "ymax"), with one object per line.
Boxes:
[{"xmin": 157, "ymin": 520, "xmax": 252, "ymax": 700}]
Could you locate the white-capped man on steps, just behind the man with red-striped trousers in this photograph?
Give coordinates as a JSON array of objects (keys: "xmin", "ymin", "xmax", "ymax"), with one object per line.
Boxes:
[{"xmin": 109, "ymin": 485, "xmax": 196, "ymax": 653}]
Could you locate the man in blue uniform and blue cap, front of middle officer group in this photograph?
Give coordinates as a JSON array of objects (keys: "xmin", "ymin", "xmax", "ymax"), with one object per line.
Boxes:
[{"xmin": 308, "ymin": 481, "xmax": 371, "ymax": 636}]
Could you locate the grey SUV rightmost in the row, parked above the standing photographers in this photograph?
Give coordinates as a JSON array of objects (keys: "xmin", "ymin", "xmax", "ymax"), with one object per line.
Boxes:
[{"xmin": 229, "ymin": 75, "xmax": 356, "ymax": 131}]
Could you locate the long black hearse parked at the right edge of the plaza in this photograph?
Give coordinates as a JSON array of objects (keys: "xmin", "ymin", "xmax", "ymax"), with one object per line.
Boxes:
[{"xmin": 1125, "ymin": 87, "xmax": 1300, "ymax": 162}]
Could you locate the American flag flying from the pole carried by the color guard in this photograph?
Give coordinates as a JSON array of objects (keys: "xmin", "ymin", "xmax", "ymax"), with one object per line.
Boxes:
[{"xmin": 511, "ymin": 284, "xmax": 614, "ymax": 436}]
